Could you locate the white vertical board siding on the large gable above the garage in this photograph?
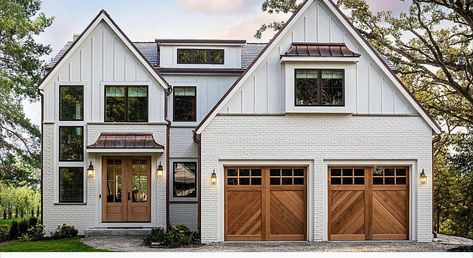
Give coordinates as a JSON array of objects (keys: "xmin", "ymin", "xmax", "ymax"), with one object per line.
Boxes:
[{"xmin": 220, "ymin": 1, "xmax": 416, "ymax": 115}]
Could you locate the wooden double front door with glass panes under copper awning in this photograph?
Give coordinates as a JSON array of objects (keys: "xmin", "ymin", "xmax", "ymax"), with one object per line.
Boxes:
[{"xmin": 102, "ymin": 157, "xmax": 151, "ymax": 222}]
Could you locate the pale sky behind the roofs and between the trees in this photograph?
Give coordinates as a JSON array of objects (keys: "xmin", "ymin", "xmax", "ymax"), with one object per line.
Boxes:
[{"xmin": 24, "ymin": 0, "xmax": 409, "ymax": 125}]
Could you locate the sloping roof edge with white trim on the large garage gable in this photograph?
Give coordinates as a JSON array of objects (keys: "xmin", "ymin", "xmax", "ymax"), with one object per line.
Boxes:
[{"xmin": 195, "ymin": 0, "xmax": 441, "ymax": 134}]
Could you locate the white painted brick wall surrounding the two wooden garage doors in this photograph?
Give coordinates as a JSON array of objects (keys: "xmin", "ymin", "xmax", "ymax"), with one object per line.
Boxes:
[{"xmin": 201, "ymin": 115, "xmax": 432, "ymax": 242}]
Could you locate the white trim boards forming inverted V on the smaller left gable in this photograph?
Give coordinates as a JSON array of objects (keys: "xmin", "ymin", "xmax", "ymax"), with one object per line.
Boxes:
[{"xmin": 39, "ymin": 12, "xmax": 168, "ymax": 90}]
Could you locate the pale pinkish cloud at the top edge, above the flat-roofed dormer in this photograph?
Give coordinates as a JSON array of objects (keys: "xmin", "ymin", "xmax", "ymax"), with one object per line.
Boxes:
[{"xmin": 180, "ymin": 0, "xmax": 261, "ymax": 15}]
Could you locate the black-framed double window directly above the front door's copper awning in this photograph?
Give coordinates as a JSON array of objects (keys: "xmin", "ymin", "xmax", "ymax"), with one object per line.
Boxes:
[{"xmin": 105, "ymin": 86, "xmax": 148, "ymax": 122}]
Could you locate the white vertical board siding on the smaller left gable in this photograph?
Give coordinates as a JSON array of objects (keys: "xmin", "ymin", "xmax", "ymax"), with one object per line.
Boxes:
[{"xmin": 44, "ymin": 21, "xmax": 165, "ymax": 122}]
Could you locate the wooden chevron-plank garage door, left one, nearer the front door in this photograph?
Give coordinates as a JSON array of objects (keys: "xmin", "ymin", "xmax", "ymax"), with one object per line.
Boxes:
[{"xmin": 225, "ymin": 168, "xmax": 307, "ymax": 241}]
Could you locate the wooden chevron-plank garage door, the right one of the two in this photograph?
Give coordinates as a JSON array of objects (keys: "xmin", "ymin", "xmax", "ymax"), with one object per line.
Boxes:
[{"xmin": 329, "ymin": 167, "xmax": 409, "ymax": 240}]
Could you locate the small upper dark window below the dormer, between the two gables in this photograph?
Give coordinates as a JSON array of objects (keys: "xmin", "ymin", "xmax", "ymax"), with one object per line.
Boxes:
[{"xmin": 173, "ymin": 87, "xmax": 197, "ymax": 122}]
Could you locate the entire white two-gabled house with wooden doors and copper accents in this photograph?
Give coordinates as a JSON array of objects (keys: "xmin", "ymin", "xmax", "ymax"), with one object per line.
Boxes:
[{"xmin": 39, "ymin": 0, "xmax": 440, "ymax": 242}]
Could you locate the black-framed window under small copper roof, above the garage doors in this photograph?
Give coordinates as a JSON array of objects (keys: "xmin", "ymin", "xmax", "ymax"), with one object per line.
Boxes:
[{"xmin": 295, "ymin": 69, "xmax": 345, "ymax": 106}]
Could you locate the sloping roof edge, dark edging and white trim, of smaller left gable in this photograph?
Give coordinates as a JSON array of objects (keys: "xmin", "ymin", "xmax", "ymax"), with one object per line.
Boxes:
[{"xmin": 38, "ymin": 10, "xmax": 169, "ymax": 90}]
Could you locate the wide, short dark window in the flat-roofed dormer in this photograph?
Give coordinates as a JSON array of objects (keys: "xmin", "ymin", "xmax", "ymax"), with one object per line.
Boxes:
[{"xmin": 177, "ymin": 48, "xmax": 225, "ymax": 64}]
